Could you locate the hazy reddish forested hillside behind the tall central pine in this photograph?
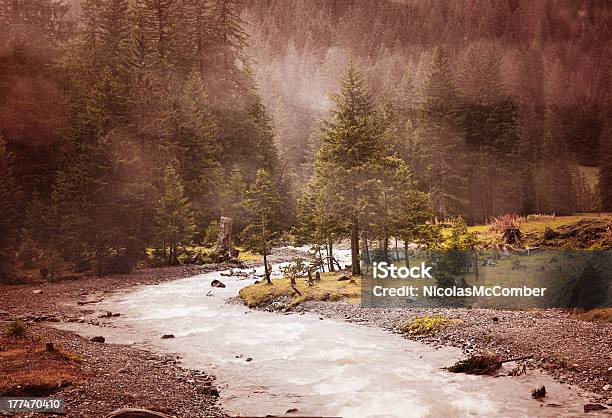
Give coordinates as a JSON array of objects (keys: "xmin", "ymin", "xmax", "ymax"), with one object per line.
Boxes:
[{"xmin": 243, "ymin": 0, "xmax": 612, "ymax": 222}]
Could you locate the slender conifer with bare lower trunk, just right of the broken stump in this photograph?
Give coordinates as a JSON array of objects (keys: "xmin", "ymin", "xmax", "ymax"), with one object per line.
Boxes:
[{"xmin": 242, "ymin": 169, "xmax": 282, "ymax": 284}]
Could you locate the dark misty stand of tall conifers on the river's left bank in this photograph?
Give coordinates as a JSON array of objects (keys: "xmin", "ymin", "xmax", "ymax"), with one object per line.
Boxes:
[{"xmin": 0, "ymin": 0, "xmax": 284, "ymax": 273}]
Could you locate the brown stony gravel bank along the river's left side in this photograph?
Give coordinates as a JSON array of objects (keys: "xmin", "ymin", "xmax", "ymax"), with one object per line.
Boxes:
[{"xmin": 0, "ymin": 248, "xmax": 301, "ymax": 417}]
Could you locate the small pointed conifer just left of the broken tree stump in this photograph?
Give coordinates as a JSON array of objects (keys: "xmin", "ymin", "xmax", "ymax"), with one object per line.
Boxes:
[{"xmin": 156, "ymin": 163, "xmax": 195, "ymax": 266}]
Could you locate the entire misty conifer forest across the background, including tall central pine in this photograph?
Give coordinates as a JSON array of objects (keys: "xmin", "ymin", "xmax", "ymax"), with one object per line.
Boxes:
[{"xmin": 0, "ymin": 0, "xmax": 612, "ymax": 277}]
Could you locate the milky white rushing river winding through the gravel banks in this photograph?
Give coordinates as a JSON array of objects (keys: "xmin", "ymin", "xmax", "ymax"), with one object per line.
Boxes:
[{"xmin": 57, "ymin": 250, "xmax": 604, "ymax": 417}]
